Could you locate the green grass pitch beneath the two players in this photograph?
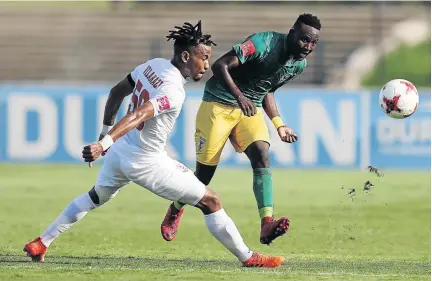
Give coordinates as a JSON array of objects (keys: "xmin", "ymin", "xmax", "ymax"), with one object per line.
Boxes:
[{"xmin": 0, "ymin": 165, "xmax": 431, "ymax": 281}]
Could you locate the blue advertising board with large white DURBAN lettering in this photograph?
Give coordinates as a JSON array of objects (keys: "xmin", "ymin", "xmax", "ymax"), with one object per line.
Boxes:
[{"xmin": 0, "ymin": 85, "xmax": 431, "ymax": 169}]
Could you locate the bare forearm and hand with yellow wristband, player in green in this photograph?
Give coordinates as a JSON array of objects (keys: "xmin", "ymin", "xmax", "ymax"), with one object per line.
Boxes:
[{"xmin": 262, "ymin": 90, "xmax": 297, "ymax": 143}]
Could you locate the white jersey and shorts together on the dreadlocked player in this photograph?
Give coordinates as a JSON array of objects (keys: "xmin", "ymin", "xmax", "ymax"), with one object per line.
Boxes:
[{"xmin": 95, "ymin": 59, "xmax": 206, "ymax": 206}]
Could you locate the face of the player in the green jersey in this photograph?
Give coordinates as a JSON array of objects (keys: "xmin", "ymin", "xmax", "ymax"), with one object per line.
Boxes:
[{"xmin": 291, "ymin": 24, "xmax": 319, "ymax": 60}]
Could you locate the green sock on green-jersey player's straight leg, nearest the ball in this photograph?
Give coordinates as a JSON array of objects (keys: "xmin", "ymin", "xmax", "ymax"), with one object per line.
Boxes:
[{"xmin": 253, "ymin": 168, "xmax": 273, "ymax": 219}]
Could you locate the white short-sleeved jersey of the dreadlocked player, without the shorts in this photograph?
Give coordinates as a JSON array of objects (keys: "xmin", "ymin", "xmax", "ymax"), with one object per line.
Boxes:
[{"xmin": 111, "ymin": 58, "xmax": 186, "ymax": 162}]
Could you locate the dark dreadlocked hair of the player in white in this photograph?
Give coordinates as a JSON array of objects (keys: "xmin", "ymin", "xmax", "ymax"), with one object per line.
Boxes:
[{"xmin": 166, "ymin": 21, "xmax": 216, "ymax": 49}]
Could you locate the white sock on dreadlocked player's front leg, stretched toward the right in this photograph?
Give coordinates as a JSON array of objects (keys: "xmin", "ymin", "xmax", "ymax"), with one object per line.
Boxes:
[{"xmin": 204, "ymin": 209, "xmax": 252, "ymax": 262}]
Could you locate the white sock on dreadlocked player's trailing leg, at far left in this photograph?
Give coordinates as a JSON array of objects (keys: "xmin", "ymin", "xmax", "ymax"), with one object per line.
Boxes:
[{"xmin": 41, "ymin": 192, "xmax": 96, "ymax": 247}]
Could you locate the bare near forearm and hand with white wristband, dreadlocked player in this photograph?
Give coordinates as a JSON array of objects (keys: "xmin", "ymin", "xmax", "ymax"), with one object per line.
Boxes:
[{"xmin": 82, "ymin": 101, "xmax": 155, "ymax": 163}]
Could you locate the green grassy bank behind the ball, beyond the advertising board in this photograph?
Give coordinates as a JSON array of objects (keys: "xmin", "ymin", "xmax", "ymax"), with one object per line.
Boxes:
[{"xmin": 362, "ymin": 40, "xmax": 431, "ymax": 88}]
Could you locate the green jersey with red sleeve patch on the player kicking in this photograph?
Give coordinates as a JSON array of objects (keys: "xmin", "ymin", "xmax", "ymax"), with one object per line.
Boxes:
[{"xmin": 203, "ymin": 32, "xmax": 307, "ymax": 107}]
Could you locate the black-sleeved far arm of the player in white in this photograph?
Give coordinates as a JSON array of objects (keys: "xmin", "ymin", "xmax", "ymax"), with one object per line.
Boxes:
[{"xmin": 100, "ymin": 74, "xmax": 135, "ymax": 139}]
